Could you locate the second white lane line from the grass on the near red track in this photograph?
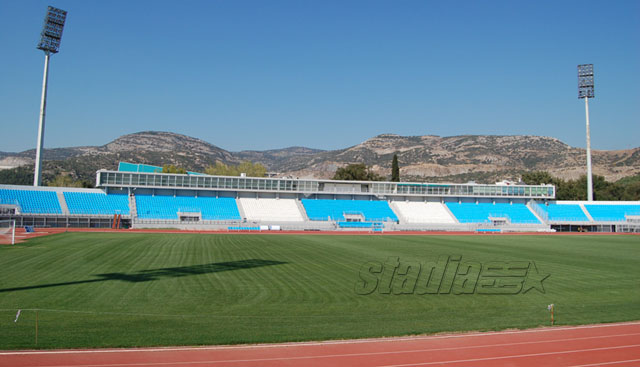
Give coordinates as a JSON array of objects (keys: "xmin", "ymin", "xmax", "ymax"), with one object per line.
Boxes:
[{"xmin": 6, "ymin": 333, "xmax": 640, "ymax": 367}]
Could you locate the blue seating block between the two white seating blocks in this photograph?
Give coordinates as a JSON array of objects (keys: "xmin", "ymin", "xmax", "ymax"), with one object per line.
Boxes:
[{"xmin": 301, "ymin": 199, "xmax": 398, "ymax": 221}]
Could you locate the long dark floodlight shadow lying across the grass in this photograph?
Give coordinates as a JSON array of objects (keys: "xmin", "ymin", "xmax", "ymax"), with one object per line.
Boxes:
[{"xmin": 0, "ymin": 259, "xmax": 286, "ymax": 293}]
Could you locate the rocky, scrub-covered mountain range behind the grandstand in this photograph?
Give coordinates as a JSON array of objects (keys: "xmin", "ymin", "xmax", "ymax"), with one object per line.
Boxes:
[{"xmin": 0, "ymin": 131, "xmax": 640, "ymax": 183}]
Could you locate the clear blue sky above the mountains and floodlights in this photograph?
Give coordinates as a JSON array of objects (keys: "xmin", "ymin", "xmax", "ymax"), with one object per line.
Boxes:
[{"xmin": 0, "ymin": 0, "xmax": 640, "ymax": 151}]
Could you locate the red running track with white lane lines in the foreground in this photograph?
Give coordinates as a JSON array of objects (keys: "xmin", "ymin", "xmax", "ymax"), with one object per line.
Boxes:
[{"xmin": 0, "ymin": 322, "xmax": 640, "ymax": 367}]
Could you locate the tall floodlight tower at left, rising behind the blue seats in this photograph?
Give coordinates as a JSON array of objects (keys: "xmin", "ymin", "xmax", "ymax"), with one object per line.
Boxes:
[{"xmin": 33, "ymin": 6, "xmax": 67, "ymax": 186}]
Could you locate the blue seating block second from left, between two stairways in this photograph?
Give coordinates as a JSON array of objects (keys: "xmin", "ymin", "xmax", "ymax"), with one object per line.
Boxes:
[{"xmin": 63, "ymin": 191, "xmax": 129, "ymax": 215}]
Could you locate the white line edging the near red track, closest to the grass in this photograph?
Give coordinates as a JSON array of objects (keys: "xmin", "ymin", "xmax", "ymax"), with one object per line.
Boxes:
[{"xmin": 0, "ymin": 321, "xmax": 640, "ymax": 356}]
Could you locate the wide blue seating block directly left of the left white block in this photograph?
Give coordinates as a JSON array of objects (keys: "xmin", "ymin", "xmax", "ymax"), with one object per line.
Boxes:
[{"xmin": 136, "ymin": 195, "xmax": 241, "ymax": 220}]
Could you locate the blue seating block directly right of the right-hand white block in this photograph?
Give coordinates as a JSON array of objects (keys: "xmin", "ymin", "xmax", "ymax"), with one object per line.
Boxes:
[{"xmin": 446, "ymin": 203, "xmax": 540, "ymax": 224}]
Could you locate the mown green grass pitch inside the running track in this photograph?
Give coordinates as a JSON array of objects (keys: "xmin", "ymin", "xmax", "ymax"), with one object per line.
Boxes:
[{"xmin": 0, "ymin": 233, "xmax": 640, "ymax": 349}]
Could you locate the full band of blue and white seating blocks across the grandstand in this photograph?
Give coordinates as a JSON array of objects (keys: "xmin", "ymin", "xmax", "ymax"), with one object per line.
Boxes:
[{"xmin": 0, "ymin": 186, "xmax": 640, "ymax": 228}]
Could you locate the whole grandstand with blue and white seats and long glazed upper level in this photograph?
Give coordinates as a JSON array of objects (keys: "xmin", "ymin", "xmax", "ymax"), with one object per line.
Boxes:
[{"xmin": 0, "ymin": 162, "xmax": 640, "ymax": 232}]
